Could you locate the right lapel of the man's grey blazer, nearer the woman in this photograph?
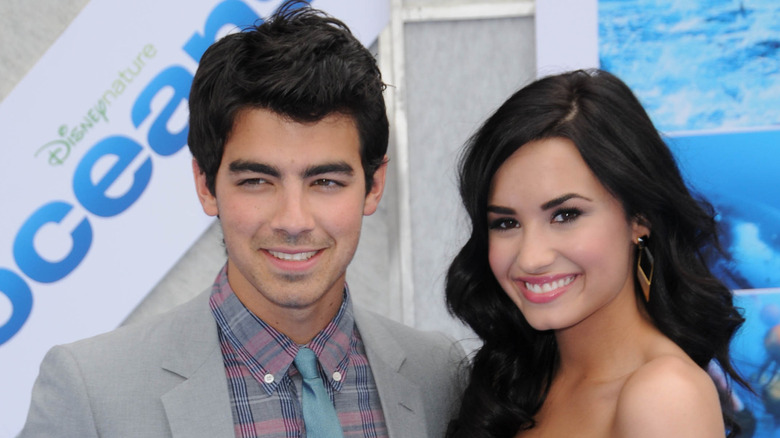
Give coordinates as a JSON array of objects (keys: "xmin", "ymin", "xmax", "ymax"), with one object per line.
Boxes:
[{"xmin": 354, "ymin": 306, "xmax": 426, "ymax": 438}]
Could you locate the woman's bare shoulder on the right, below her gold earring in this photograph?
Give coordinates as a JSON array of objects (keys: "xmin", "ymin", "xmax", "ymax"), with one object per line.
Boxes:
[{"xmin": 614, "ymin": 354, "xmax": 725, "ymax": 438}]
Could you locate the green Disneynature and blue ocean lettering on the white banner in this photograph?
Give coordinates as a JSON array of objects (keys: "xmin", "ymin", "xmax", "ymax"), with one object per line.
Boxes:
[{"xmin": 0, "ymin": 0, "xmax": 274, "ymax": 345}]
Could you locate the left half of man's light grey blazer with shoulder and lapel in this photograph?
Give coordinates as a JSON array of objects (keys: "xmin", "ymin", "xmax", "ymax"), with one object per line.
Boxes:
[{"xmin": 20, "ymin": 292, "xmax": 233, "ymax": 437}]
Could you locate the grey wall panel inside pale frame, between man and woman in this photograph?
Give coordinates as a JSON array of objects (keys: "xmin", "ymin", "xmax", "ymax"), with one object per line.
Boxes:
[{"xmin": 405, "ymin": 11, "xmax": 535, "ymax": 346}]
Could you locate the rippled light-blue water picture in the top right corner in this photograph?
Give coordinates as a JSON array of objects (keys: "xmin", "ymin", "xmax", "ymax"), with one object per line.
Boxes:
[{"xmin": 598, "ymin": 0, "xmax": 780, "ymax": 132}]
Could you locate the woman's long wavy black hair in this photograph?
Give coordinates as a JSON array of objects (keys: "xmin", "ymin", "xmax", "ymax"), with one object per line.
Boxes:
[{"xmin": 446, "ymin": 70, "xmax": 745, "ymax": 438}]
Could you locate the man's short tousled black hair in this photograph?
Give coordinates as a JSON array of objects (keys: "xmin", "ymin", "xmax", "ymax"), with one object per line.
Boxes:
[{"xmin": 188, "ymin": 0, "xmax": 389, "ymax": 194}]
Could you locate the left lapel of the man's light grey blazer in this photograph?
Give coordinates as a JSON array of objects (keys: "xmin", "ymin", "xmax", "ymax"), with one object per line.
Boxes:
[{"xmin": 157, "ymin": 293, "xmax": 235, "ymax": 438}]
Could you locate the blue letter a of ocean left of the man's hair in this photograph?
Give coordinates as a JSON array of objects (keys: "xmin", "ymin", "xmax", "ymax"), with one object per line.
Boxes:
[{"xmin": 131, "ymin": 66, "xmax": 192, "ymax": 157}]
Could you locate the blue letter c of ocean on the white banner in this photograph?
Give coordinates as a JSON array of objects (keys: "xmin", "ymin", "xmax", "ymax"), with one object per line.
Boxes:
[{"xmin": 14, "ymin": 201, "xmax": 92, "ymax": 283}]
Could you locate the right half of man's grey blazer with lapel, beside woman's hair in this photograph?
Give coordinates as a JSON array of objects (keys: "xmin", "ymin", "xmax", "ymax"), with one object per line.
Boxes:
[{"xmin": 355, "ymin": 306, "xmax": 465, "ymax": 438}]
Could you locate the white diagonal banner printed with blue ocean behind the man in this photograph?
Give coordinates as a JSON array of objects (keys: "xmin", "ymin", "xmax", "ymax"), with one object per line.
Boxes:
[{"xmin": 0, "ymin": 0, "xmax": 389, "ymax": 436}]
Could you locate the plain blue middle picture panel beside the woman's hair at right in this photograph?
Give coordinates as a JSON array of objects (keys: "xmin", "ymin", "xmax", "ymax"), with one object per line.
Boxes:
[{"xmin": 667, "ymin": 129, "xmax": 780, "ymax": 289}]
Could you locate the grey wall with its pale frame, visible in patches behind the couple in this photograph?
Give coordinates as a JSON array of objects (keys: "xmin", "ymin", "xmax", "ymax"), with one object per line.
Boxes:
[{"xmin": 0, "ymin": 0, "xmax": 535, "ymax": 350}]
